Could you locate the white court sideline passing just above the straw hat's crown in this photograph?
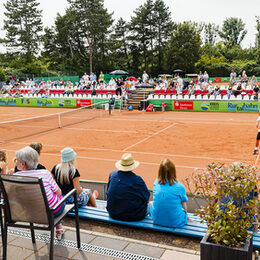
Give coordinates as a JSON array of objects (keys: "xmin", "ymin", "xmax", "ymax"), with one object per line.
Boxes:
[{"xmin": 10, "ymin": 142, "xmax": 250, "ymax": 163}]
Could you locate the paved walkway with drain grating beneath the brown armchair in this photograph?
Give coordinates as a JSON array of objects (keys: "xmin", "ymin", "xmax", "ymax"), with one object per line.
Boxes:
[{"xmin": 0, "ymin": 224, "xmax": 200, "ymax": 260}]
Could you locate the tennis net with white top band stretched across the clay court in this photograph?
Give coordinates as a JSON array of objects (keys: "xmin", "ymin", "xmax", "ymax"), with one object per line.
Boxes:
[{"xmin": 0, "ymin": 102, "xmax": 109, "ymax": 143}]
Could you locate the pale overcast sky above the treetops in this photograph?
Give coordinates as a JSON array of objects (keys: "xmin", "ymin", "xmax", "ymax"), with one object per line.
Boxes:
[{"xmin": 0, "ymin": 0, "xmax": 260, "ymax": 47}]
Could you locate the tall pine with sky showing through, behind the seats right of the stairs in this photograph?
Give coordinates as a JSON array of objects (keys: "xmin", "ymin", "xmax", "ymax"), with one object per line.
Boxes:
[{"xmin": 130, "ymin": 0, "xmax": 173, "ymax": 73}]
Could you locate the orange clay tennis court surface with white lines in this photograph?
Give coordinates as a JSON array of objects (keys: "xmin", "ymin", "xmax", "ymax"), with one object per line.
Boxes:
[{"xmin": 0, "ymin": 107, "xmax": 259, "ymax": 188}]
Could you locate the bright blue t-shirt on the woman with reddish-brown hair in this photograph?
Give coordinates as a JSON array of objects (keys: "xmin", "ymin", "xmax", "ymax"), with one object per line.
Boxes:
[{"xmin": 150, "ymin": 180, "xmax": 188, "ymax": 227}]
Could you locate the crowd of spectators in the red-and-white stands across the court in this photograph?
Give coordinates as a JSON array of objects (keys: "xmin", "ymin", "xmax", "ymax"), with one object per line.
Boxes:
[{"xmin": 0, "ymin": 70, "xmax": 259, "ymax": 99}]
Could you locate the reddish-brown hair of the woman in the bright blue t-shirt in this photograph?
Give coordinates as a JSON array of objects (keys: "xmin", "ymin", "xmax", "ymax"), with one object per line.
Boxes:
[{"xmin": 158, "ymin": 159, "xmax": 177, "ymax": 185}]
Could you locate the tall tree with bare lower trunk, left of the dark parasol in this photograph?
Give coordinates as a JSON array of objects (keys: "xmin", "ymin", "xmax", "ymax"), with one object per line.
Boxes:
[{"xmin": 68, "ymin": 0, "xmax": 113, "ymax": 72}]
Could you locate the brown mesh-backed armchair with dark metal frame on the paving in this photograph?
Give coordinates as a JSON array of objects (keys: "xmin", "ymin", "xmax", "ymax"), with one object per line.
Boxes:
[{"xmin": 0, "ymin": 174, "xmax": 80, "ymax": 260}]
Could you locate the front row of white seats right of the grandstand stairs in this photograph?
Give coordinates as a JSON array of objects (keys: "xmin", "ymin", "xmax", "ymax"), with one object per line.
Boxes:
[{"xmin": 148, "ymin": 94, "xmax": 255, "ymax": 101}]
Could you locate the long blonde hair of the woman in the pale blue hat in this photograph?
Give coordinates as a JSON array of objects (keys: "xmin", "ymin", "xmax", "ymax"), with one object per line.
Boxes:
[{"xmin": 55, "ymin": 160, "xmax": 76, "ymax": 184}]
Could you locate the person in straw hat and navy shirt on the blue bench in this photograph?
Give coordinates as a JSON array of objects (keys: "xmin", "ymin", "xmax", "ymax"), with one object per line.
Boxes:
[{"xmin": 107, "ymin": 153, "xmax": 150, "ymax": 221}]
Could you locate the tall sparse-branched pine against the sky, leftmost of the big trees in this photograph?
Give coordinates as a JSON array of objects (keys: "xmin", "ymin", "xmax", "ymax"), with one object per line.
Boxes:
[{"xmin": 4, "ymin": 0, "xmax": 42, "ymax": 60}]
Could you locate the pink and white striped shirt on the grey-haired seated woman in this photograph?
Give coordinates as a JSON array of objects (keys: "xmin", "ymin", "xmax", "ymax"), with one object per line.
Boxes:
[{"xmin": 14, "ymin": 170, "xmax": 62, "ymax": 213}]
